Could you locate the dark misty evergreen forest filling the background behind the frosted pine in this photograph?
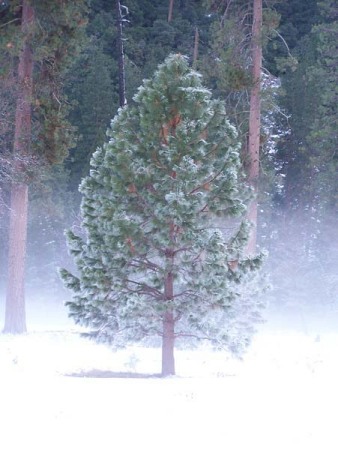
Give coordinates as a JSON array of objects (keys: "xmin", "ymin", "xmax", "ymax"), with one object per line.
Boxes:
[{"xmin": 0, "ymin": 0, "xmax": 338, "ymax": 330}]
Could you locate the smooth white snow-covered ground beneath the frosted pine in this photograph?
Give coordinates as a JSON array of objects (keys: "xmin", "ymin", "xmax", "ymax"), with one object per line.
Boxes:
[{"xmin": 0, "ymin": 298, "xmax": 338, "ymax": 450}]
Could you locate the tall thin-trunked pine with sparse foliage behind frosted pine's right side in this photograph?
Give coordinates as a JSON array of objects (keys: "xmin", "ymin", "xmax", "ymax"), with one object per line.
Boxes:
[{"xmin": 202, "ymin": 0, "xmax": 279, "ymax": 253}]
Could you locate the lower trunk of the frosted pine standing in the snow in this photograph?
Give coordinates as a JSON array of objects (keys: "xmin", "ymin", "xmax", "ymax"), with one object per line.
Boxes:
[{"xmin": 162, "ymin": 272, "xmax": 175, "ymax": 376}]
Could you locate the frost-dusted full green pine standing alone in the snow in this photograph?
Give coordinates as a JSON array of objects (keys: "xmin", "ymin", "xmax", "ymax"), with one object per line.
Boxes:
[{"xmin": 60, "ymin": 55, "xmax": 262, "ymax": 375}]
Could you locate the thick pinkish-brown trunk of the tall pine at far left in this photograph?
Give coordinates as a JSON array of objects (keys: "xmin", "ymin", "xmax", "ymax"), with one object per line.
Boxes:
[{"xmin": 4, "ymin": 0, "xmax": 34, "ymax": 333}]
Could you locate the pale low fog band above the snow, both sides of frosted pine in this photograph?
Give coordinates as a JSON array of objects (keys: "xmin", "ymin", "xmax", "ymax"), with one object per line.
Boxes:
[{"xmin": 0, "ymin": 212, "xmax": 338, "ymax": 342}]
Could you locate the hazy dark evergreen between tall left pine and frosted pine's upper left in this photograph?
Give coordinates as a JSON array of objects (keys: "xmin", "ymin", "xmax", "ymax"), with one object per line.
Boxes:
[{"xmin": 65, "ymin": 43, "xmax": 118, "ymax": 192}]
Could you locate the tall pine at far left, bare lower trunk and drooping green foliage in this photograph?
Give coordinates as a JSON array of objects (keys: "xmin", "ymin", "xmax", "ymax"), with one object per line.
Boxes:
[{"xmin": 0, "ymin": 0, "xmax": 86, "ymax": 333}]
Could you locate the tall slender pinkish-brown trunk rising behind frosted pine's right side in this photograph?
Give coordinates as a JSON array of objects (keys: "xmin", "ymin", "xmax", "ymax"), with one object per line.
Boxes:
[{"xmin": 247, "ymin": 0, "xmax": 262, "ymax": 255}]
